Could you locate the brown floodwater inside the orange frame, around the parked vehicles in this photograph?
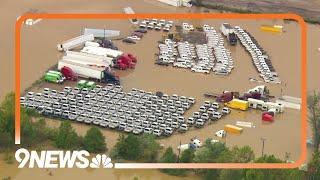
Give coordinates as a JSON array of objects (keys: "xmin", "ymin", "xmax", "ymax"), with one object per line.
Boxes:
[{"xmin": 22, "ymin": 17, "xmax": 301, "ymax": 160}]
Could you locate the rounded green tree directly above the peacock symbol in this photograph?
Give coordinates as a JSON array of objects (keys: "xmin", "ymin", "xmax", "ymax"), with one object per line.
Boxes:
[{"xmin": 83, "ymin": 127, "xmax": 107, "ymax": 153}]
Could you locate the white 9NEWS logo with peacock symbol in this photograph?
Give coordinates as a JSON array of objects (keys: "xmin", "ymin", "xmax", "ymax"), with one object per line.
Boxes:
[{"xmin": 15, "ymin": 148, "xmax": 113, "ymax": 169}]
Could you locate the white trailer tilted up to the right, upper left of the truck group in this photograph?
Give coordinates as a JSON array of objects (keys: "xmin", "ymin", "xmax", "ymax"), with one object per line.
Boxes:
[{"xmin": 57, "ymin": 34, "xmax": 94, "ymax": 51}]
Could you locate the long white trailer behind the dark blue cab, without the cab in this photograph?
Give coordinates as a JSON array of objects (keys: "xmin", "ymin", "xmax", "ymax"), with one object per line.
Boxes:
[{"xmin": 58, "ymin": 60, "xmax": 105, "ymax": 80}]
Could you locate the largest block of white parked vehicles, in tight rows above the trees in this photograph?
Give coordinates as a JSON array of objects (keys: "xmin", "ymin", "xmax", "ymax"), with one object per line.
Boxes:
[{"xmin": 20, "ymin": 84, "xmax": 200, "ymax": 136}]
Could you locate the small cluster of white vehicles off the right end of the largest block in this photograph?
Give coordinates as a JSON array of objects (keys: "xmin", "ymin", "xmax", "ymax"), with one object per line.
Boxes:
[{"xmin": 187, "ymin": 101, "xmax": 231, "ymax": 128}]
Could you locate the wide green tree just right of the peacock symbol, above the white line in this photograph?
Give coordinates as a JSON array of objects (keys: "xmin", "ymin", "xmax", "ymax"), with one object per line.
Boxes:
[{"xmin": 112, "ymin": 134, "xmax": 143, "ymax": 160}]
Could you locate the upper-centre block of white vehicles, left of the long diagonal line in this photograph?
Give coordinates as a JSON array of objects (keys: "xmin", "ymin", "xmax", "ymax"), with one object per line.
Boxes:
[{"xmin": 156, "ymin": 23, "xmax": 233, "ymax": 75}]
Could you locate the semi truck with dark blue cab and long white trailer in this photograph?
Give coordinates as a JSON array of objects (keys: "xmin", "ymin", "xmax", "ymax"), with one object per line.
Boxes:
[{"xmin": 58, "ymin": 60, "xmax": 120, "ymax": 84}]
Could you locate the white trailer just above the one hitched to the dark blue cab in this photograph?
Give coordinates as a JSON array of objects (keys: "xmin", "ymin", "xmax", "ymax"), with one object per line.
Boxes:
[{"xmin": 62, "ymin": 51, "xmax": 113, "ymax": 66}]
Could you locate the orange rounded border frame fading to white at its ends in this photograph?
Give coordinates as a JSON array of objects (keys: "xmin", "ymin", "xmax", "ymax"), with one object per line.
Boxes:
[{"xmin": 15, "ymin": 13, "xmax": 307, "ymax": 169}]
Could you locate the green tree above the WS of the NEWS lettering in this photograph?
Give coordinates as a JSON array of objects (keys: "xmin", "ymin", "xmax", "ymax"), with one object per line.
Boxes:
[{"xmin": 55, "ymin": 121, "xmax": 81, "ymax": 150}]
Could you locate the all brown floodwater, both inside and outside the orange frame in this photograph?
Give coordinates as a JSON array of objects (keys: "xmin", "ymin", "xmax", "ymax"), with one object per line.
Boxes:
[{"xmin": 0, "ymin": 0, "xmax": 320, "ymax": 179}]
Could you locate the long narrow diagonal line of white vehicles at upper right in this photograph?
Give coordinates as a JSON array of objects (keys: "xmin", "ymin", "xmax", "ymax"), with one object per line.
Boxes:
[{"xmin": 234, "ymin": 26, "xmax": 281, "ymax": 84}]
